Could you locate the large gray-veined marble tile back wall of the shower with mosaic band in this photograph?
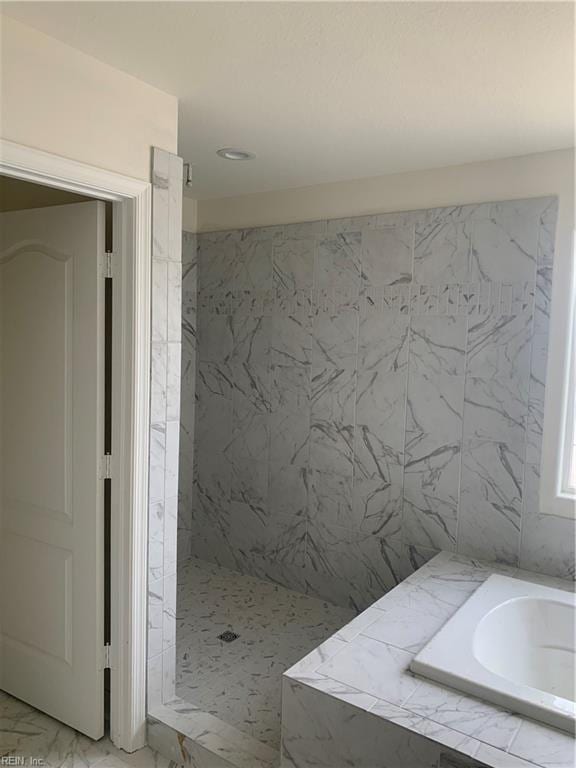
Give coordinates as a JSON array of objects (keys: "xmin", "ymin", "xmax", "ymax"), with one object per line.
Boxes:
[{"xmin": 179, "ymin": 198, "xmax": 574, "ymax": 608}]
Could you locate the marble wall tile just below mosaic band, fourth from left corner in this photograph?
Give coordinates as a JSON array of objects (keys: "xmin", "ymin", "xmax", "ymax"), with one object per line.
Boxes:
[{"xmin": 312, "ymin": 309, "xmax": 358, "ymax": 368}]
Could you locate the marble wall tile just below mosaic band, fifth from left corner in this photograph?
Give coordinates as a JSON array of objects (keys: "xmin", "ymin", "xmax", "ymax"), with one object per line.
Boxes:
[{"xmin": 358, "ymin": 304, "xmax": 410, "ymax": 374}]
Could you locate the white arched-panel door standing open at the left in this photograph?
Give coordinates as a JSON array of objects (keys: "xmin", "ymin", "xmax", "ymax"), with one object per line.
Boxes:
[{"xmin": 0, "ymin": 202, "xmax": 105, "ymax": 739}]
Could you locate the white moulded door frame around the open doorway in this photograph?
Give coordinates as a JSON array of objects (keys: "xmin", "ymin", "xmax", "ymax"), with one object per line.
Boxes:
[{"xmin": 0, "ymin": 139, "xmax": 152, "ymax": 752}]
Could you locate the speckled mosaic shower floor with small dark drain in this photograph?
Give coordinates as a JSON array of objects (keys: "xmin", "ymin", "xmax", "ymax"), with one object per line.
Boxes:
[{"xmin": 176, "ymin": 559, "xmax": 354, "ymax": 749}]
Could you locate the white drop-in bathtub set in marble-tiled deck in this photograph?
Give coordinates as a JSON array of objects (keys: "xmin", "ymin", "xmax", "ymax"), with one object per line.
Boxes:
[{"xmin": 410, "ymin": 575, "xmax": 576, "ymax": 734}]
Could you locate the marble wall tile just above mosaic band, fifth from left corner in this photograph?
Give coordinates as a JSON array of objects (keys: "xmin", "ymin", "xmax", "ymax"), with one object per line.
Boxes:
[{"xmin": 362, "ymin": 226, "xmax": 414, "ymax": 286}]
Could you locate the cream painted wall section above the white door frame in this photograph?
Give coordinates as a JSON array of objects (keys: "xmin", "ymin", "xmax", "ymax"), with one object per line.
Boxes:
[{"xmin": 0, "ymin": 16, "xmax": 178, "ymax": 180}]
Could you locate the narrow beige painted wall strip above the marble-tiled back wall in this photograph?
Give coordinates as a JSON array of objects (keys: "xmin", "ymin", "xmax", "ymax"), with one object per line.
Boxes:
[{"xmin": 198, "ymin": 150, "xmax": 574, "ymax": 232}]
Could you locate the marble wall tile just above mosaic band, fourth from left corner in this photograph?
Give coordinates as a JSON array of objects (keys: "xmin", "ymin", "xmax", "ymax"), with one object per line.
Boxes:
[{"xmin": 314, "ymin": 231, "xmax": 362, "ymax": 292}]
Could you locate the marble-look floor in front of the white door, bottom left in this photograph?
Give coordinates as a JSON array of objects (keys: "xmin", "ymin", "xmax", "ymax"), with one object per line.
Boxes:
[{"xmin": 0, "ymin": 691, "xmax": 176, "ymax": 768}]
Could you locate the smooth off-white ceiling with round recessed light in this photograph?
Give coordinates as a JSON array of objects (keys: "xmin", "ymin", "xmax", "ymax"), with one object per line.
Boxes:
[{"xmin": 2, "ymin": 2, "xmax": 574, "ymax": 198}]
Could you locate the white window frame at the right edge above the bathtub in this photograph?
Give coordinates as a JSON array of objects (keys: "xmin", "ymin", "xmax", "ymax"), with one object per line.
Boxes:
[{"xmin": 540, "ymin": 226, "xmax": 576, "ymax": 518}]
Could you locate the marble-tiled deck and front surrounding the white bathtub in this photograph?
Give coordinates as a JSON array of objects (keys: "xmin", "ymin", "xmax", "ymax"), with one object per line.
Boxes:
[{"xmin": 282, "ymin": 552, "xmax": 575, "ymax": 768}]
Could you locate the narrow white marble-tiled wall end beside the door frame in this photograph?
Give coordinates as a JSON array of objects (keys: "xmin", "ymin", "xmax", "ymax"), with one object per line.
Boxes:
[{"xmin": 148, "ymin": 148, "xmax": 182, "ymax": 706}]
